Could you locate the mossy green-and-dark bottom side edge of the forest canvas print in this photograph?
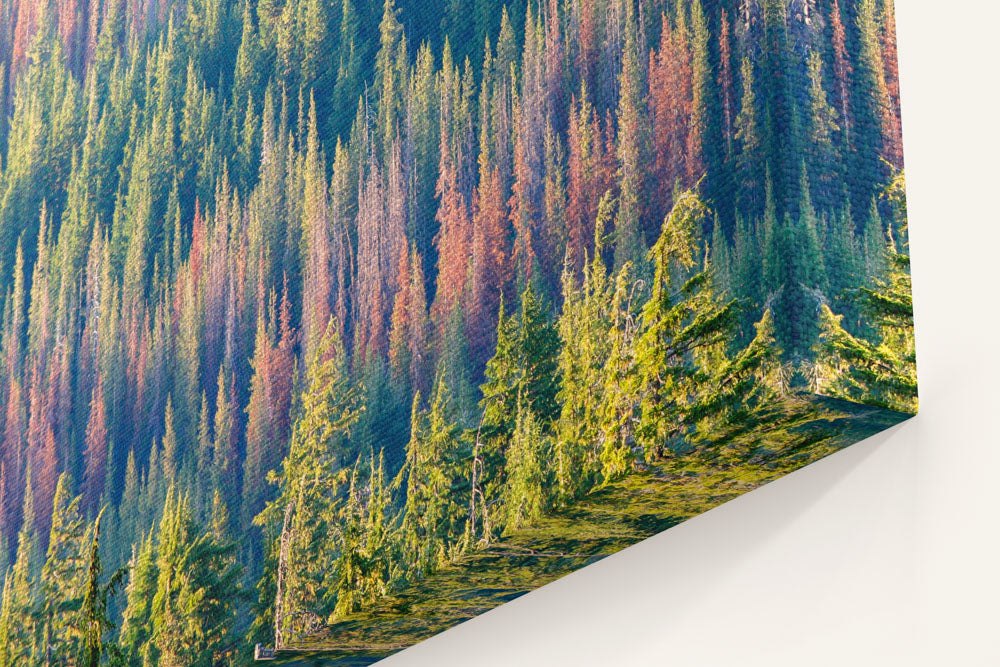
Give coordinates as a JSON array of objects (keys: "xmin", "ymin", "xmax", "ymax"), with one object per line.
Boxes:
[{"xmin": 273, "ymin": 397, "xmax": 909, "ymax": 667}]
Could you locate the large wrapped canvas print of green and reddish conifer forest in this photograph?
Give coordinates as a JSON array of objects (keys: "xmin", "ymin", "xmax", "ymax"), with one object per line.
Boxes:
[{"xmin": 0, "ymin": 0, "xmax": 917, "ymax": 667}]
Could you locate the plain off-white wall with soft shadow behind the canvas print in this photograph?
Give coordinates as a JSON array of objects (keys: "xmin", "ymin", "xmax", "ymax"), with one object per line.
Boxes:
[{"xmin": 384, "ymin": 0, "xmax": 1000, "ymax": 667}]
